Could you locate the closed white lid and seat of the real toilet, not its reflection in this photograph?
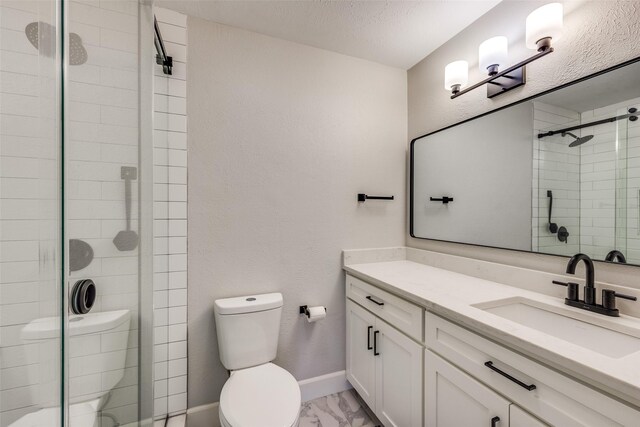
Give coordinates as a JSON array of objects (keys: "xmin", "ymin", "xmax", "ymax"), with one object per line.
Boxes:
[{"xmin": 220, "ymin": 363, "xmax": 301, "ymax": 427}]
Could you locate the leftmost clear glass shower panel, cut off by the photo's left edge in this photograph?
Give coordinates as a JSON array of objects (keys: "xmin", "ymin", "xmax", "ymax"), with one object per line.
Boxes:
[{"xmin": 0, "ymin": 0, "xmax": 62, "ymax": 426}]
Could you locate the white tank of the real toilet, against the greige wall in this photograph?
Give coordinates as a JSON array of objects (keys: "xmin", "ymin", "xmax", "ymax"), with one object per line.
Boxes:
[{"xmin": 213, "ymin": 293, "xmax": 282, "ymax": 370}]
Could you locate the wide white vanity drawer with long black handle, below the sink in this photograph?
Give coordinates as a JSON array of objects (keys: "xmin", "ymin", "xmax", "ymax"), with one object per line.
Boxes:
[{"xmin": 425, "ymin": 313, "xmax": 640, "ymax": 427}]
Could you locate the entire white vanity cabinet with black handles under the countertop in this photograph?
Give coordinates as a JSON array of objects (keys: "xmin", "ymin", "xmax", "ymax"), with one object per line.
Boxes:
[{"xmin": 346, "ymin": 275, "xmax": 640, "ymax": 427}]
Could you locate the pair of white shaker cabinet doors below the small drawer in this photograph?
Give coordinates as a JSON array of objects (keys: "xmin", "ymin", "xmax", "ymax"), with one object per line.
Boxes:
[{"xmin": 347, "ymin": 280, "xmax": 424, "ymax": 427}]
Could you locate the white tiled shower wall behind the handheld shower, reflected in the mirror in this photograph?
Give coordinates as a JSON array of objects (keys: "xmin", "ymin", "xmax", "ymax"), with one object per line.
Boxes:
[{"xmin": 532, "ymin": 101, "xmax": 581, "ymax": 255}]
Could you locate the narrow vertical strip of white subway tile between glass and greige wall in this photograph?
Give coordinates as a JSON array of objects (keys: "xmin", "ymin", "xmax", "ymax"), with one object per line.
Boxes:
[{"xmin": 153, "ymin": 8, "xmax": 187, "ymax": 419}]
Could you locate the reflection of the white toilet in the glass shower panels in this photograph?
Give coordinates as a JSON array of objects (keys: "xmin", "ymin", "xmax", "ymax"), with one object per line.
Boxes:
[{"xmin": 10, "ymin": 310, "xmax": 131, "ymax": 427}]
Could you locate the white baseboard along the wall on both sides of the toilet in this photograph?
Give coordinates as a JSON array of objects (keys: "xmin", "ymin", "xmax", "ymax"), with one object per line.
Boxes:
[{"xmin": 187, "ymin": 371, "xmax": 352, "ymax": 427}]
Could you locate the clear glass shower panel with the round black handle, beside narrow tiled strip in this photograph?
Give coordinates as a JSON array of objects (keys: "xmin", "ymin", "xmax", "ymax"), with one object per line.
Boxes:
[{"xmin": 64, "ymin": 0, "xmax": 153, "ymax": 427}]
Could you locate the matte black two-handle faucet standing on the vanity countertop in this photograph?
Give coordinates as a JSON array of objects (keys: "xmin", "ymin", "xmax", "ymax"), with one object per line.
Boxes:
[{"xmin": 553, "ymin": 254, "xmax": 637, "ymax": 316}]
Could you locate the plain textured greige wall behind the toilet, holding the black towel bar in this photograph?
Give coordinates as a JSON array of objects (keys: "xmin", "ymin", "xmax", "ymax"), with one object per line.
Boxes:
[{"xmin": 187, "ymin": 18, "xmax": 407, "ymax": 407}]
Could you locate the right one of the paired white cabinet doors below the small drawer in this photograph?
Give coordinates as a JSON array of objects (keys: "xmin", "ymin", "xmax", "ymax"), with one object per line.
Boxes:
[{"xmin": 374, "ymin": 319, "xmax": 423, "ymax": 427}]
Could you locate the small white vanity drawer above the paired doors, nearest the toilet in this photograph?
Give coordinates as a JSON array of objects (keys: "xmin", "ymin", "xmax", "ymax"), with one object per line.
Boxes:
[{"xmin": 347, "ymin": 274, "xmax": 424, "ymax": 342}]
